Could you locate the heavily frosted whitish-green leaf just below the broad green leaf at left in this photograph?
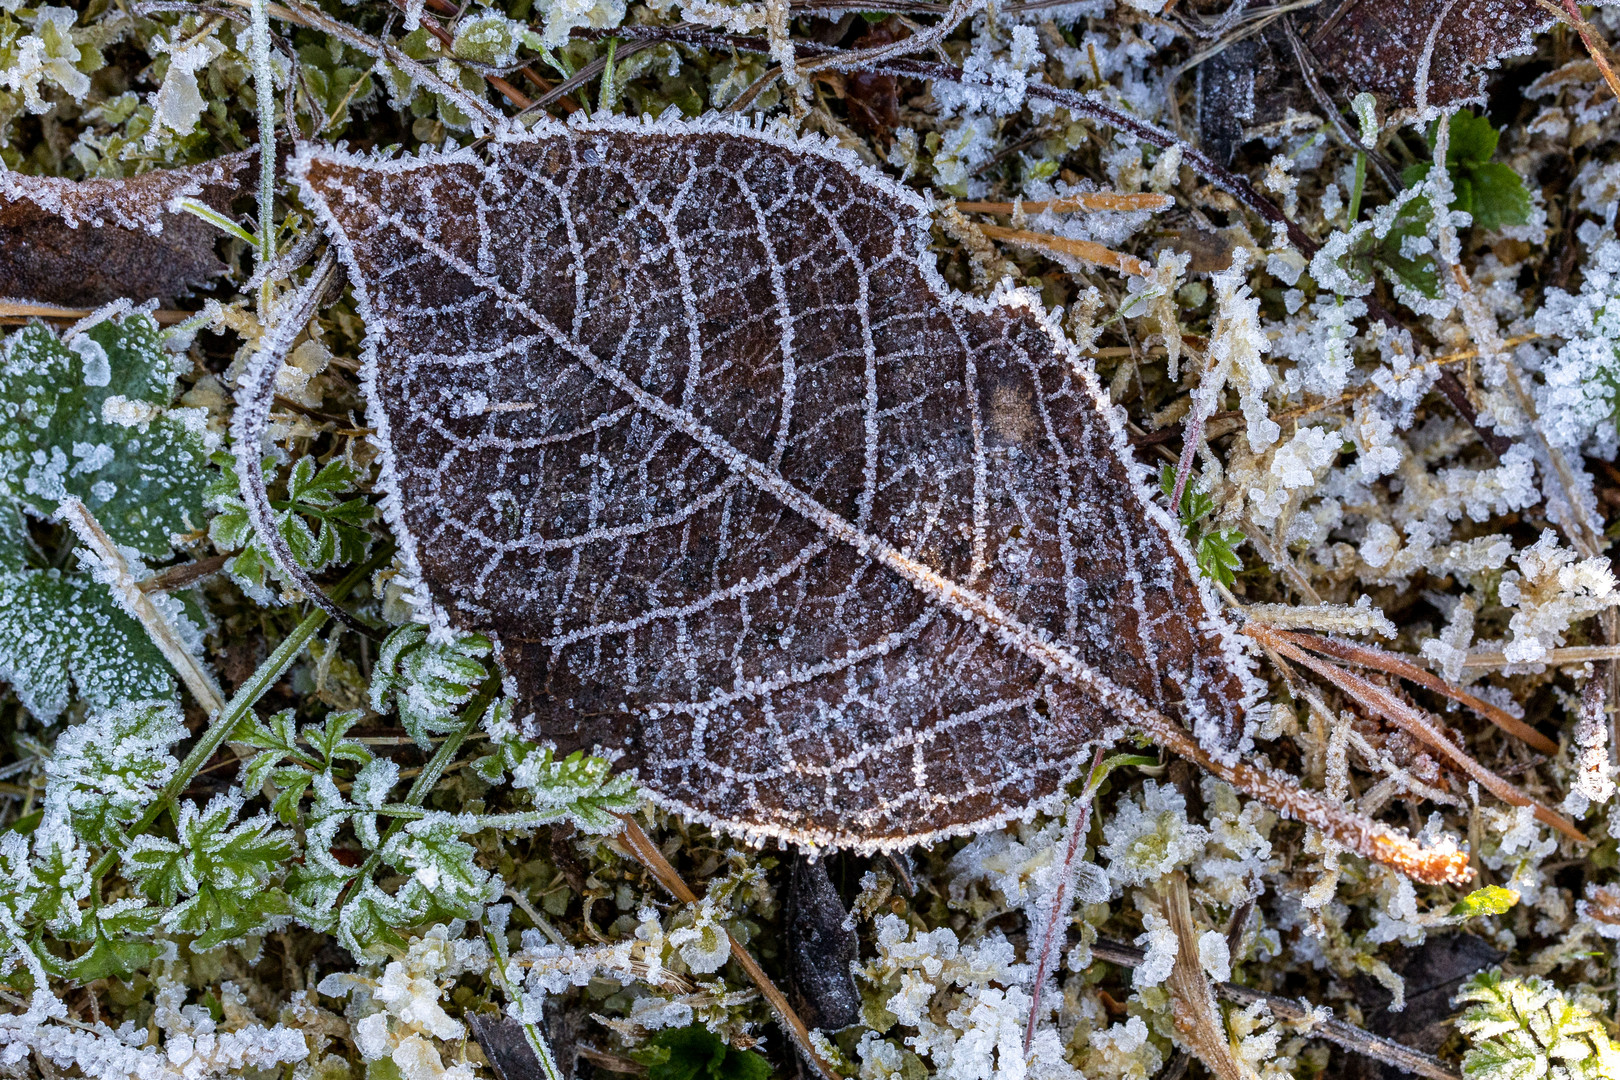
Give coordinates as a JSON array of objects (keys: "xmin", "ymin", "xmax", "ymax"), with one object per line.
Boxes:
[{"xmin": 45, "ymin": 701, "xmax": 186, "ymax": 847}]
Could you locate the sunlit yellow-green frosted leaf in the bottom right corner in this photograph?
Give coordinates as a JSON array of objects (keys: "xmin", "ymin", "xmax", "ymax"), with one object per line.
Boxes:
[{"xmin": 1456, "ymin": 972, "xmax": 1620, "ymax": 1080}]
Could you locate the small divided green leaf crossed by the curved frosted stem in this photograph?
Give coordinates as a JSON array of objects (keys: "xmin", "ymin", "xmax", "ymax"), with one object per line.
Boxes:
[{"xmin": 207, "ymin": 453, "xmax": 374, "ymax": 604}]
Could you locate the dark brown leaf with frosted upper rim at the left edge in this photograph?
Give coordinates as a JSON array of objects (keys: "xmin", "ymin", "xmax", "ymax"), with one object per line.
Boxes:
[{"xmin": 0, "ymin": 151, "xmax": 256, "ymax": 308}]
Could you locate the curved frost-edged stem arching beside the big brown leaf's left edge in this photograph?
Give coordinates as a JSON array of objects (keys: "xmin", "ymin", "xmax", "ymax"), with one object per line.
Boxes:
[{"xmin": 230, "ymin": 251, "xmax": 381, "ymax": 638}]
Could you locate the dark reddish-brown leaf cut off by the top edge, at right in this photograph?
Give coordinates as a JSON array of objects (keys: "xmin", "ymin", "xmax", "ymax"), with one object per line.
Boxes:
[{"xmin": 1307, "ymin": 0, "xmax": 1594, "ymax": 112}]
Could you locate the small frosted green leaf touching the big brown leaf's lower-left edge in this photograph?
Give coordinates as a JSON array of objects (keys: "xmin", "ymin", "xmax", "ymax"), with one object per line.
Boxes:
[{"xmin": 371, "ymin": 623, "xmax": 491, "ymax": 750}]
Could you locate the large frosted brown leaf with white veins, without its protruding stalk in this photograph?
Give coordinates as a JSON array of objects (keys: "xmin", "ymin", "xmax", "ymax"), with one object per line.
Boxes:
[{"xmin": 293, "ymin": 120, "xmax": 1257, "ymax": 848}]
